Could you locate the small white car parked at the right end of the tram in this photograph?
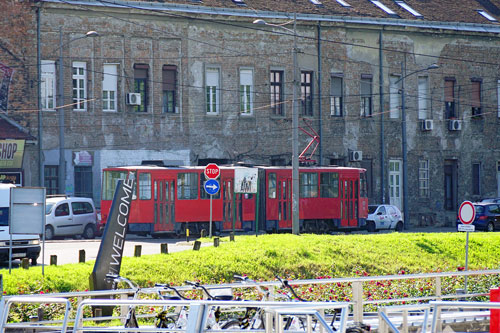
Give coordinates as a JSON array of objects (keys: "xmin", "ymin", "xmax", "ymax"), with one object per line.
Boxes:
[{"xmin": 366, "ymin": 205, "xmax": 404, "ymax": 232}]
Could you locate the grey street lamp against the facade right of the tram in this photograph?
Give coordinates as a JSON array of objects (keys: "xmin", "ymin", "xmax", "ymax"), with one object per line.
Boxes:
[{"xmin": 394, "ymin": 58, "xmax": 439, "ymax": 229}]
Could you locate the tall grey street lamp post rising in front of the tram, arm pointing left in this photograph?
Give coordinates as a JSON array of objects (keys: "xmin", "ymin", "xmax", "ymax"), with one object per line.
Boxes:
[{"xmin": 253, "ymin": 13, "xmax": 300, "ymax": 235}]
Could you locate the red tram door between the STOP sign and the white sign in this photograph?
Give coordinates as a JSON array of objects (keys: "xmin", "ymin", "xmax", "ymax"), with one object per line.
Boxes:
[{"xmin": 221, "ymin": 175, "xmax": 242, "ymax": 231}]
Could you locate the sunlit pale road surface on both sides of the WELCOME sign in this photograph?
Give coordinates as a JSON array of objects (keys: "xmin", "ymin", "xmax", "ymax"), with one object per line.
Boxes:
[{"xmin": 38, "ymin": 235, "xmax": 202, "ymax": 265}]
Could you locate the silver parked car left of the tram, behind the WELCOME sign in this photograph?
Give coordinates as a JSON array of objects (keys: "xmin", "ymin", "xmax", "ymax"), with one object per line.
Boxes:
[{"xmin": 45, "ymin": 196, "xmax": 97, "ymax": 239}]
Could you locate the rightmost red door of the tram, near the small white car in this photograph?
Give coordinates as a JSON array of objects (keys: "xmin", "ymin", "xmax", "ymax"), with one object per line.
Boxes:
[{"xmin": 340, "ymin": 178, "xmax": 359, "ymax": 227}]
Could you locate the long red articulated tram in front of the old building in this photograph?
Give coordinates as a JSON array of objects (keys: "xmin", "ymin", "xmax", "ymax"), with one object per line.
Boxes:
[{"xmin": 101, "ymin": 166, "xmax": 368, "ymax": 237}]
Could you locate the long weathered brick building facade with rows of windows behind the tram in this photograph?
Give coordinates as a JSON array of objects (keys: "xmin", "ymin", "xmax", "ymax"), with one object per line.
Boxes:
[{"xmin": 0, "ymin": 0, "xmax": 500, "ymax": 226}]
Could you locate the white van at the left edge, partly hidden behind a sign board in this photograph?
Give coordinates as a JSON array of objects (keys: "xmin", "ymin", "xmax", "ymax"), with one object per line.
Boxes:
[{"xmin": 0, "ymin": 184, "xmax": 40, "ymax": 265}]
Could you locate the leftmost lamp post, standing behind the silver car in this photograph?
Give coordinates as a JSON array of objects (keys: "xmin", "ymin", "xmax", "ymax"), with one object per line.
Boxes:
[{"xmin": 56, "ymin": 27, "xmax": 99, "ymax": 194}]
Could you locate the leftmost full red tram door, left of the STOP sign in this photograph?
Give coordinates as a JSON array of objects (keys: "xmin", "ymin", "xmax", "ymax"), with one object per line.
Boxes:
[{"xmin": 153, "ymin": 179, "xmax": 175, "ymax": 232}]
